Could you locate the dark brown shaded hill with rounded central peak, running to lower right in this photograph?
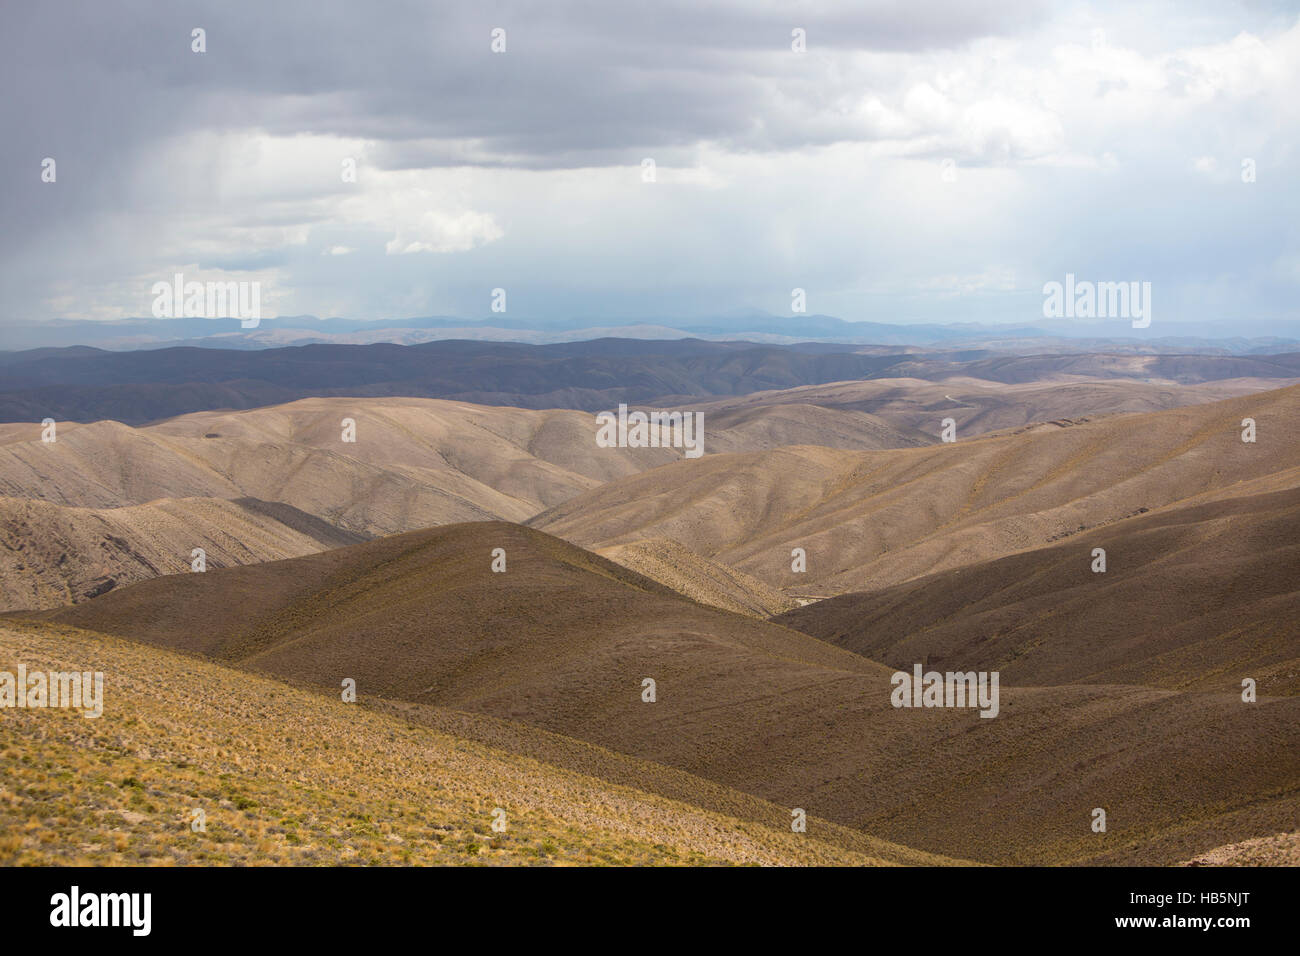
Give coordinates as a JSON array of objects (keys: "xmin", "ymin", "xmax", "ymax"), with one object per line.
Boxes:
[{"xmin": 30, "ymin": 522, "xmax": 1300, "ymax": 862}]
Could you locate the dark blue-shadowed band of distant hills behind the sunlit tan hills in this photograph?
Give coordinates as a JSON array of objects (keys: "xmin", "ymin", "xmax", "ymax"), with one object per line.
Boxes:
[{"xmin": 0, "ymin": 338, "xmax": 1300, "ymax": 424}]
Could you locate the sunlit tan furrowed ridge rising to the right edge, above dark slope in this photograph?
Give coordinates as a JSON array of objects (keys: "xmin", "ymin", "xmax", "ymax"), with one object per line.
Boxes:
[{"xmin": 529, "ymin": 386, "xmax": 1300, "ymax": 597}]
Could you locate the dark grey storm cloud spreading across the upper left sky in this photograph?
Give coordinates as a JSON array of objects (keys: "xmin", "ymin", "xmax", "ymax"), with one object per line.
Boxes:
[{"xmin": 0, "ymin": 3, "xmax": 1037, "ymax": 165}]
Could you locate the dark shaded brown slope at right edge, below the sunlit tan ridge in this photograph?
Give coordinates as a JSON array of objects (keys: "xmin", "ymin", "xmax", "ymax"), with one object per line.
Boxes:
[{"xmin": 777, "ymin": 488, "xmax": 1300, "ymax": 695}]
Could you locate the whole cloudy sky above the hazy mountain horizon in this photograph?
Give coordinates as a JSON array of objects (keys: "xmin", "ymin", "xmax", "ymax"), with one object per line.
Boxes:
[{"xmin": 0, "ymin": 0, "xmax": 1300, "ymax": 334}]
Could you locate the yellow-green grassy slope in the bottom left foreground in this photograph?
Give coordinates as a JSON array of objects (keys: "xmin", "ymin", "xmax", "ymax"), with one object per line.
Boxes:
[{"xmin": 0, "ymin": 626, "xmax": 920, "ymax": 865}]
